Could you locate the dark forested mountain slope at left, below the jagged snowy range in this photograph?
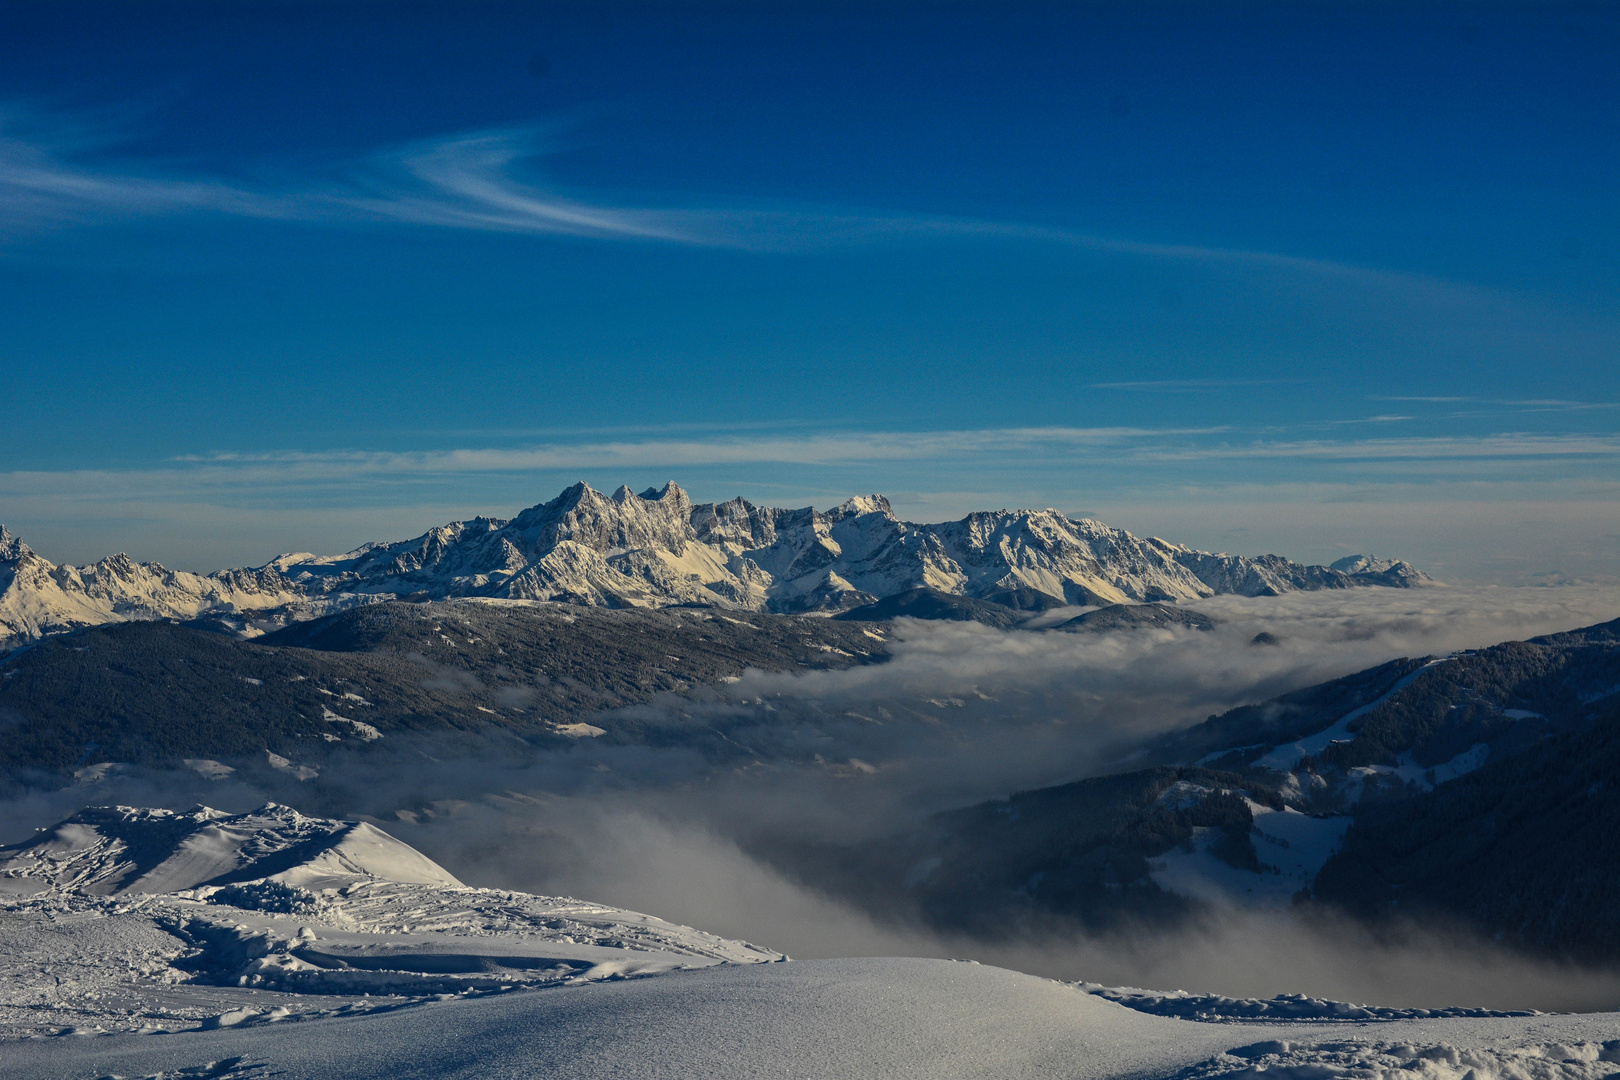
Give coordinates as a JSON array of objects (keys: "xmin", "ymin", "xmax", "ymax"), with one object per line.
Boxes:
[{"xmin": 0, "ymin": 601, "xmax": 886, "ymax": 776}]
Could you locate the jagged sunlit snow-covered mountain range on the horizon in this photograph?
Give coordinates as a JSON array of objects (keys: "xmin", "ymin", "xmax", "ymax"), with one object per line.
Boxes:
[{"xmin": 0, "ymin": 483, "xmax": 1427, "ymax": 648}]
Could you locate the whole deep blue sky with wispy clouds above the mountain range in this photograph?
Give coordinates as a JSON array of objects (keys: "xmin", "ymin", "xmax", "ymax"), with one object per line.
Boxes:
[{"xmin": 0, "ymin": 3, "xmax": 1620, "ymax": 581}]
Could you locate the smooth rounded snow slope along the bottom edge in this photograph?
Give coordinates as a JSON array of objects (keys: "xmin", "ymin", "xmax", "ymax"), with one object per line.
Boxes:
[{"xmin": 5, "ymin": 959, "xmax": 1620, "ymax": 1080}]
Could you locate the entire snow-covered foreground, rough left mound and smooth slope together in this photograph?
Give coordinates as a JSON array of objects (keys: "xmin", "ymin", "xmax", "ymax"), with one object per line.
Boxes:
[{"xmin": 9, "ymin": 805, "xmax": 1620, "ymax": 1080}]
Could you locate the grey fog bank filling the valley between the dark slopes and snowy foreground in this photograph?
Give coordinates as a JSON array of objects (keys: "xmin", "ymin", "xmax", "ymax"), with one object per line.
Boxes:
[{"xmin": 12, "ymin": 586, "xmax": 1620, "ymax": 1010}]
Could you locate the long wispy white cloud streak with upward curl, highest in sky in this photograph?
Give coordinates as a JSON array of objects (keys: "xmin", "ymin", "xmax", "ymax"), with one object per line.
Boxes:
[{"xmin": 0, "ymin": 104, "xmax": 1548, "ymax": 312}]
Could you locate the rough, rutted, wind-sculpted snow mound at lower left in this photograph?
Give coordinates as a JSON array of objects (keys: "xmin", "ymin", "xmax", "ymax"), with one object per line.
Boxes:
[{"xmin": 0, "ymin": 805, "xmax": 782, "ymax": 1036}]
